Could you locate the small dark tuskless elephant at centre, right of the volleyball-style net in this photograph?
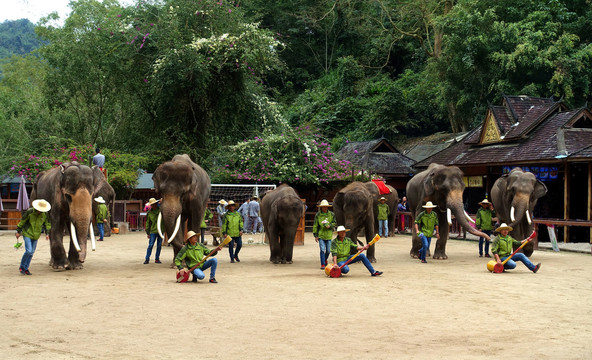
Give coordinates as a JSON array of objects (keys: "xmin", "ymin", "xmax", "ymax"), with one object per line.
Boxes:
[{"xmin": 261, "ymin": 184, "xmax": 304, "ymax": 264}]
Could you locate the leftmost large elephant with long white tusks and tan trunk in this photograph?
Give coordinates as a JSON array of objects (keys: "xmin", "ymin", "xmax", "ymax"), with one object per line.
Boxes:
[{"xmin": 31, "ymin": 161, "xmax": 104, "ymax": 270}]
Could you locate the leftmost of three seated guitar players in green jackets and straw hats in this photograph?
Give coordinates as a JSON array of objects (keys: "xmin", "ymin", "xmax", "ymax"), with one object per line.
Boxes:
[{"xmin": 175, "ymin": 230, "xmax": 218, "ymax": 284}]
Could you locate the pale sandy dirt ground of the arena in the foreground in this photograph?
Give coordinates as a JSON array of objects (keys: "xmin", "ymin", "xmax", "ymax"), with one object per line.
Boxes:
[{"xmin": 0, "ymin": 233, "xmax": 592, "ymax": 359}]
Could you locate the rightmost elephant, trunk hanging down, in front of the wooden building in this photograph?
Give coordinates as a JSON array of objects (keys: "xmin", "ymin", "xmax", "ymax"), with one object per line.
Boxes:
[{"xmin": 491, "ymin": 167, "xmax": 547, "ymax": 256}]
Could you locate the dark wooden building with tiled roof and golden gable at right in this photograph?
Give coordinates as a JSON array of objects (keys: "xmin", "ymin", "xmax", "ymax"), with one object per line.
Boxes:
[{"xmin": 415, "ymin": 96, "xmax": 592, "ymax": 242}]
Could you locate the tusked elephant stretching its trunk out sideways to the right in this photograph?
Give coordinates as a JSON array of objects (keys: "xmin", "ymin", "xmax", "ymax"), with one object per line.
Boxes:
[{"xmin": 407, "ymin": 163, "xmax": 489, "ymax": 260}]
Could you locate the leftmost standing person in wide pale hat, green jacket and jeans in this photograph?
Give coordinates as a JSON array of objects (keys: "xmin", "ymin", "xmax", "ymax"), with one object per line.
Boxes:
[{"xmin": 15, "ymin": 199, "xmax": 51, "ymax": 275}]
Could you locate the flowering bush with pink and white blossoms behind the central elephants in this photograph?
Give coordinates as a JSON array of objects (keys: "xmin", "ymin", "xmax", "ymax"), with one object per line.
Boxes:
[{"xmin": 212, "ymin": 126, "xmax": 351, "ymax": 184}]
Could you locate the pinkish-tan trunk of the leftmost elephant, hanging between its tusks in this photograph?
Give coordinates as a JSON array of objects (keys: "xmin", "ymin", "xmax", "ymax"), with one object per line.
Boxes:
[{"xmin": 69, "ymin": 189, "xmax": 92, "ymax": 262}]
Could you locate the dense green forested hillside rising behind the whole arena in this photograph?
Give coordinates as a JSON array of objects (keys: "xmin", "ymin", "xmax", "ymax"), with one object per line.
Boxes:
[{"xmin": 0, "ymin": 0, "xmax": 592, "ymax": 191}]
